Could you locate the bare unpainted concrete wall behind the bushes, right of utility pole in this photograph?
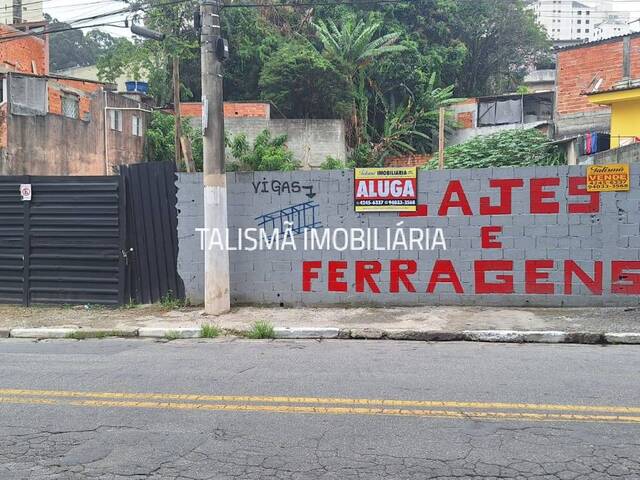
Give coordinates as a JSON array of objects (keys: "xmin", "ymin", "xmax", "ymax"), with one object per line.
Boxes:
[{"xmin": 190, "ymin": 117, "xmax": 347, "ymax": 169}]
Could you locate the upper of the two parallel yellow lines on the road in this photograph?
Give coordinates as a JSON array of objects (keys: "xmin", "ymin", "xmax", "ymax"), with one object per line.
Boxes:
[{"xmin": 0, "ymin": 389, "xmax": 640, "ymax": 414}]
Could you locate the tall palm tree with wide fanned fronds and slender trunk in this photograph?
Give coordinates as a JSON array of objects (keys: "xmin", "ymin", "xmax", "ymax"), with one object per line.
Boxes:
[{"xmin": 314, "ymin": 18, "xmax": 405, "ymax": 146}]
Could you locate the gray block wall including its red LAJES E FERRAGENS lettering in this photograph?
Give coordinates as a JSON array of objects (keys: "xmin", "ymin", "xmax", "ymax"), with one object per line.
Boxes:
[{"xmin": 178, "ymin": 165, "xmax": 640, "ymax": 306}]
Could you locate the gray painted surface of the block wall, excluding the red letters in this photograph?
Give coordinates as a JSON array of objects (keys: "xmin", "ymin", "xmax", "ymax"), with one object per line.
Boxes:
[{"xmin": 178, "ymin": 165, "xmax": 640, "ymax": 306}]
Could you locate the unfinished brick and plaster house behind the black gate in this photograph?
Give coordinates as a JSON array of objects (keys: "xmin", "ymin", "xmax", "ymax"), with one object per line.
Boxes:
[{"xmin": 0, "ymin": 26, "xmax": 149, "ymax": 175}]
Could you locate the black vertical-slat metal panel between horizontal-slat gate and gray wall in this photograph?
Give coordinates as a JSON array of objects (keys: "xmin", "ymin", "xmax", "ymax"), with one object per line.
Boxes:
[{"xmin": 120, "ymin": 162, "xmax": 184, "ymax": 303}]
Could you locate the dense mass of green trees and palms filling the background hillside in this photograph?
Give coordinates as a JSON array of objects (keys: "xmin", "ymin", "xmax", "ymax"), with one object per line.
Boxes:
[{"xmin": 91, "ymin": 0, "xmax": 549, "ymax": 166}]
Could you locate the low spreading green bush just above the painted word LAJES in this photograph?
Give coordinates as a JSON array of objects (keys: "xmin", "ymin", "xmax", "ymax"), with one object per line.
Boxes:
[{"xmin": 425, "ymin": 128, "xmax": 564, "ymax": 170}]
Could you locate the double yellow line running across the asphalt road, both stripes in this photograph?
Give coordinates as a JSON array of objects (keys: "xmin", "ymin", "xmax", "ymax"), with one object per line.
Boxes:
[{"xmin": 0, "ymin": 389, "xmax": 640, "ymax": 424}]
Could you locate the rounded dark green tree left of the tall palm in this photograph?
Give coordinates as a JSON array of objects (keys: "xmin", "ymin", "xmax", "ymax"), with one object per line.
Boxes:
[{"xmin": 259, "ymin": 42, "xmax": 351, "ymax": 118}]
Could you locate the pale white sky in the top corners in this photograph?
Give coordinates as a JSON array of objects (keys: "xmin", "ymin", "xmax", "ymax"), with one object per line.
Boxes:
[{"xmin": 43, "ymin": 0, "xmax": 640, "ymax": 37}]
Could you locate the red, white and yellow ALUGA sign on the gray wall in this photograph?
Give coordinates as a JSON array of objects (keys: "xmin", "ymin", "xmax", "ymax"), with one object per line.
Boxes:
[{"xmin": 354, "ymin": 167, "xmax": 418, "ymax": 212}]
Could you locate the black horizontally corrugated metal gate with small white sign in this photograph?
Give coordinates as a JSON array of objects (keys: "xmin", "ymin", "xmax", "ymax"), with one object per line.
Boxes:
[{"xmin": 0, "ymin": 176, "xmax": 126, "ymax": 306}]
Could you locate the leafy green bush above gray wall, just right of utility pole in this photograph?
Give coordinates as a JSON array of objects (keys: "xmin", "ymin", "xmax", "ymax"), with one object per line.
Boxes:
[{"xmin": 227, "ymin": 130, "xmax": 300, "ymax": 172}]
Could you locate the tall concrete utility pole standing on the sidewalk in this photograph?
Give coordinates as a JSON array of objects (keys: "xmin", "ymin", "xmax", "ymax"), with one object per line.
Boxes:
[{"xmin": 200, "ymin": 0, "xmax": 231, "ymax": 315}]
